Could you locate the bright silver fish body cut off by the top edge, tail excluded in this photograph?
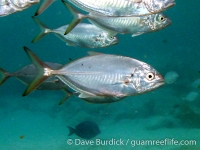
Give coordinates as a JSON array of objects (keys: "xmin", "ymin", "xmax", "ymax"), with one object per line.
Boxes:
[{"xmin": 68, "ymin": 0, "xmax": 175, "ymax": 16}]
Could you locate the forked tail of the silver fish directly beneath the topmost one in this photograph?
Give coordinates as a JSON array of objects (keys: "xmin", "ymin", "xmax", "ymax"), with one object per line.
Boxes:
[{"xmin": 62, "ymin": 0, "xmax": 87, "ymax": 35}]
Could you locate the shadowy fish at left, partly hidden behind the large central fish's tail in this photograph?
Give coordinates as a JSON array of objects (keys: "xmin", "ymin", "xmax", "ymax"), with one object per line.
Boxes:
[{"xmin": 0, "ymin": 62, "xmax": 72, "ymax": 105}]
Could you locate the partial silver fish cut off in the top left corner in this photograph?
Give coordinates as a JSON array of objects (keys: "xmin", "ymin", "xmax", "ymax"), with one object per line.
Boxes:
[{"xmin": 0, "ymin": 0, "xmax": 40, "ymax": 17}]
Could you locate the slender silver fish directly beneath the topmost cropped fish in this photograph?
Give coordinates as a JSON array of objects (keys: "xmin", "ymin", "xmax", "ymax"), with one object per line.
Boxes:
[{"xmin": 64, "ymin": 2, "xmax": 171, "ymax": 36}]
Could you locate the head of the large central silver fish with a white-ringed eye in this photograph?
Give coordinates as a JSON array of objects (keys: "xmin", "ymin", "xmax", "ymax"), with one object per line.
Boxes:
[{"xmin": 132, "ymin": 63, "xmax": 165, "ymax": 93}]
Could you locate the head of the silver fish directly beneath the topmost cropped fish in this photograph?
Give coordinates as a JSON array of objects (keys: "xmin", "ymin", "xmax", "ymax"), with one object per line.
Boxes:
[{"xmin": 145, "ymin": 13, "xmax": 171, "ymax": 31}]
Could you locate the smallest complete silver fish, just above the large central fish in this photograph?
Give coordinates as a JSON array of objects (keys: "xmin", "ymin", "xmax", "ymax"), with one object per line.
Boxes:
[{"xmin": 32, "ymin": 17, "xmax": 119, "ymax": 48}]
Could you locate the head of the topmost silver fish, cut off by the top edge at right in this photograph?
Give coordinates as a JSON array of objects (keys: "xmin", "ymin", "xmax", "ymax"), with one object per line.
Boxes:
[{"xmin": 144, "ymin": 0, "xmax": 176, "ymax": 13}]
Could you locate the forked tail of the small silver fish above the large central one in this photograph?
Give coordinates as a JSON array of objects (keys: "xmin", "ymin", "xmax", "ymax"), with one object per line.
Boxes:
[{"xmin": 31, "ymin": 16, "xmax": 51, "ymax": 43}]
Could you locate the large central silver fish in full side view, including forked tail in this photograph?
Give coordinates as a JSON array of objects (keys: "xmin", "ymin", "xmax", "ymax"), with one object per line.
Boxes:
[{"xmin": 23, "ymin": 47, "xmax": 164, "ymax": 103}]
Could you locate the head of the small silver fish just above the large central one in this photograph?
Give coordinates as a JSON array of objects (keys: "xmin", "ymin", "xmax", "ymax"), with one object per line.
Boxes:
[{"xmin": 94, "ymin": 32, "xmax": 119, "ymax": 47}]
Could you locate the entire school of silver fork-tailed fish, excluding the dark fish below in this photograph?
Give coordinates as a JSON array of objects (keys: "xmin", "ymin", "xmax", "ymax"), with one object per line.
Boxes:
[{"xmin": 0, "ymin": 0, "xmax": 175, "ymax": 104}]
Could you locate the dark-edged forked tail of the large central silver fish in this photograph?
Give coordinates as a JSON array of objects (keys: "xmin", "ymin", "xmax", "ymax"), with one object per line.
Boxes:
[{"xmin": 23, "ymin": 46, "xmax": 53, "ymax": 96}]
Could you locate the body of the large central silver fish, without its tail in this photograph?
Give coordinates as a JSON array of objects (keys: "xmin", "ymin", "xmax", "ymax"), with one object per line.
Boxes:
[{"xmin": 55, "ymin": 54, "xmax": 162, "ymax": 98}]
